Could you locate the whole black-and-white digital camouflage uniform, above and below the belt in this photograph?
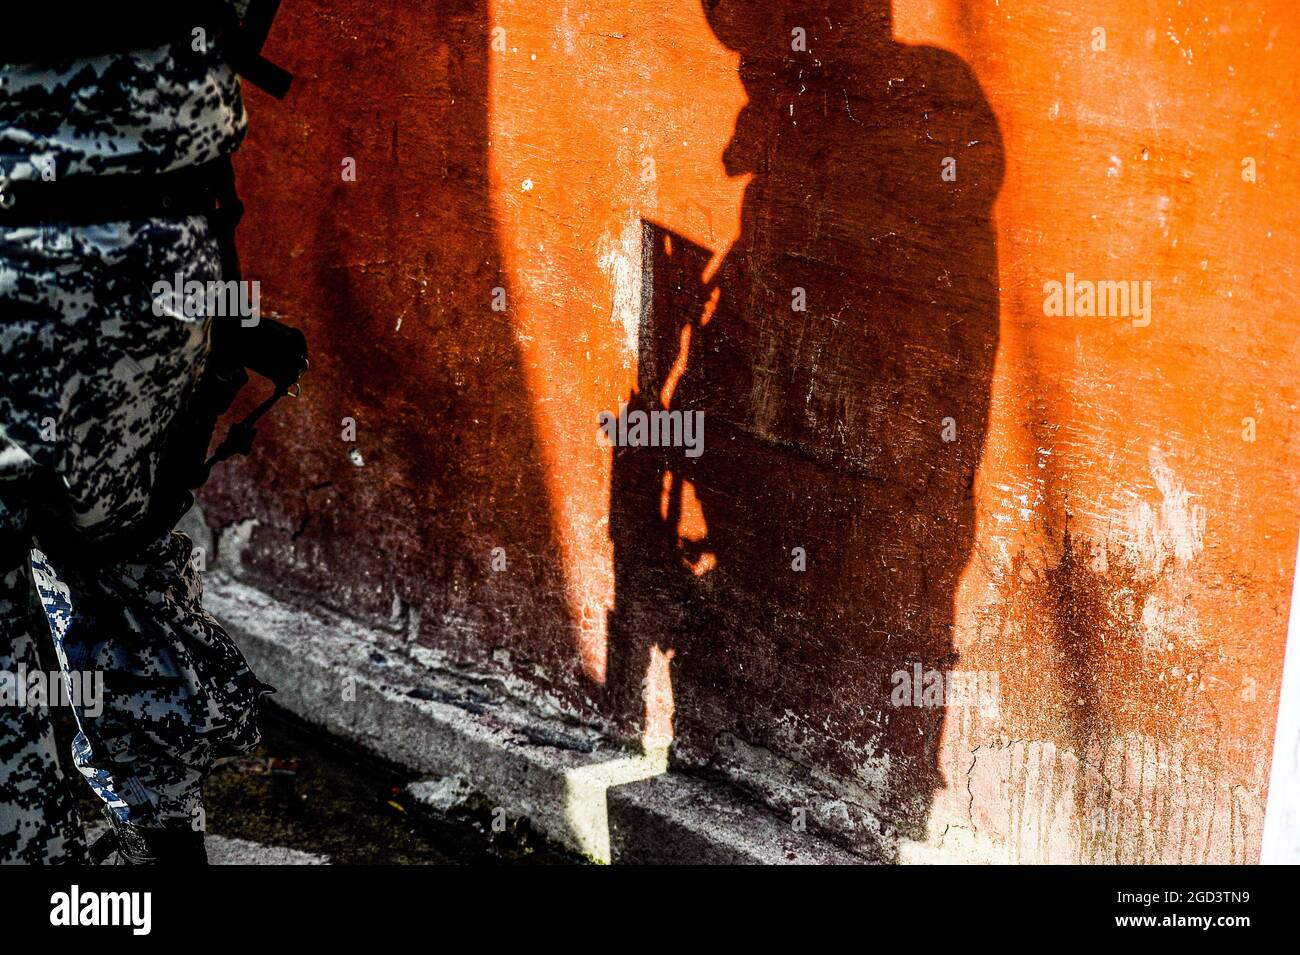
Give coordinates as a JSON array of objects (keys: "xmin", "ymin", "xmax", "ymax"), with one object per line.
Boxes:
[{"xmin": 0, "ymin": 16, "xmax": 268, "ymax": 863}]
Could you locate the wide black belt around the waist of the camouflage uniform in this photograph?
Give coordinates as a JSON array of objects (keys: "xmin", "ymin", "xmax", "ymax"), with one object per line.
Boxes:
[{"xmin": 0, "ymin": 156, "xmax": 238, "ymax": 227}]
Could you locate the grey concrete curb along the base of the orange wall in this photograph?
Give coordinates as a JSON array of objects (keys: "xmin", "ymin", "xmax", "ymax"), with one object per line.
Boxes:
[{"xmin": 205, "ymin": 573, "xmax": 865, "ymax": 864}]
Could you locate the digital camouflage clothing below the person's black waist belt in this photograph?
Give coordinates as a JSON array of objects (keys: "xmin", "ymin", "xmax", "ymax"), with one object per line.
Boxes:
[{"xmin": 0, "ymin": 217, "xmax": 269, "ymax": 863}]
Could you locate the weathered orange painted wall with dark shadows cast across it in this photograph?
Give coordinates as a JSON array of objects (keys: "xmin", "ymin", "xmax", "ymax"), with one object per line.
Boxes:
[{"xmin": 205, "ymin": 0, "xmax": 1300, "ymax": 861}]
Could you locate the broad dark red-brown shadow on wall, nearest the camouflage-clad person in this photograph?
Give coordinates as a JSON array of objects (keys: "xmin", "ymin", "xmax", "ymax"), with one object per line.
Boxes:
[{"xmin": 204, "ymin": 0, "xmax": 579, "ymax": 686}]
